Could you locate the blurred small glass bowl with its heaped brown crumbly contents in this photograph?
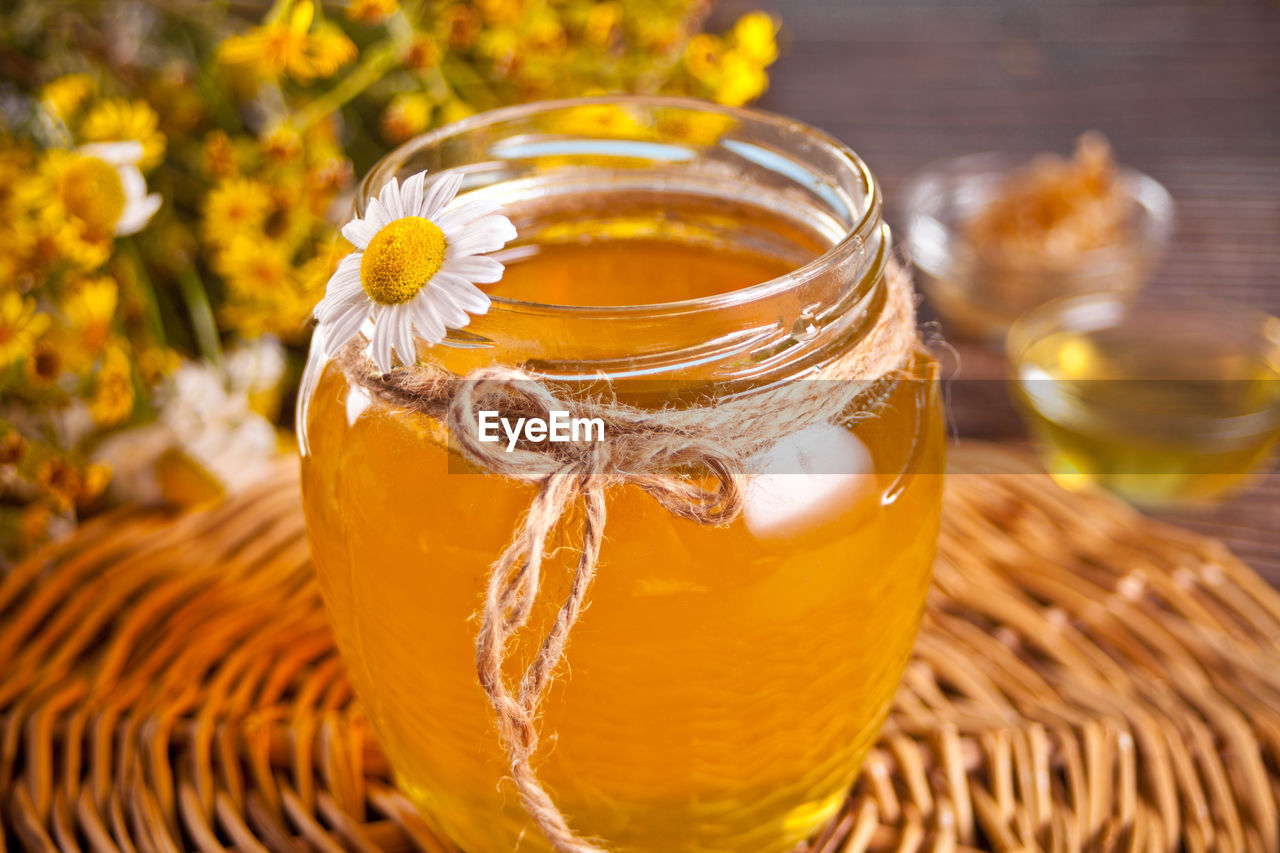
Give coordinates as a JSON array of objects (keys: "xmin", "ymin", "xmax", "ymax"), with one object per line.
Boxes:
[{"xmin": 902, "ymin": 133, "xmax": 1174, "ymax": 342}]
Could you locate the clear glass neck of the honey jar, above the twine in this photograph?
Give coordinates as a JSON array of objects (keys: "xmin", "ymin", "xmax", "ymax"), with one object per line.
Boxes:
[{"xmin": 358, "ymin": 97, "xmax": 890, "ymax": 384}]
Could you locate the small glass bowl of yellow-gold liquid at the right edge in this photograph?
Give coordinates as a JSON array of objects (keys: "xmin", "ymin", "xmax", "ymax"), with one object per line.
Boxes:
[{"xmin": 1007, "ymin": 295, "xmax": 1280, "ymax": 508}]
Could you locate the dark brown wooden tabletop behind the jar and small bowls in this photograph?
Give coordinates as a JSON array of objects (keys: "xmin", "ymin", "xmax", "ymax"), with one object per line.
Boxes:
[{"xmin": 752, "ymin": 0, "xmax": 1280, "ymax": 584}]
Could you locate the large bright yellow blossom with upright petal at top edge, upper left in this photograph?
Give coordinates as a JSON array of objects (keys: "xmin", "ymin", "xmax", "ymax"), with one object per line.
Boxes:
[{"xmin": 218, "ymin": 0, "xmax": 356, "ymax": 83}]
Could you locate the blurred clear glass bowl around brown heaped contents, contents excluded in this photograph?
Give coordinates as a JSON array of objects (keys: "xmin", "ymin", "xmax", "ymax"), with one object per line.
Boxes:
[{"xmin": 902, "ymin": 154, "xmax": 1174, "ymax": 341}]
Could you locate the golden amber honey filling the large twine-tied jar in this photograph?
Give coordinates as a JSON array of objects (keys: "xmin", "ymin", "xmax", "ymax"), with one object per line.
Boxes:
[{"xmin": 302, "ymin": 240, "xmax": 943, "ymax": 853}]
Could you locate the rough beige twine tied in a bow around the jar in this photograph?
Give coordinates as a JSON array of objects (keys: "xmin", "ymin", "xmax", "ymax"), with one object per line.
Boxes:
[{"xmin": 338, "ymin": 264, "xmax": 918, "ymax": 853}]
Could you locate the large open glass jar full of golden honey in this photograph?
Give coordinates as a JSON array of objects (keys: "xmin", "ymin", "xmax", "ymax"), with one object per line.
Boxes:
[{"xmin": 298, "ymin": 97, "xmax": 943, "ymax": 853}]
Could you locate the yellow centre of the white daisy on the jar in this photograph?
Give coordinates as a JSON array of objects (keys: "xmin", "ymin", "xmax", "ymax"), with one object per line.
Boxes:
[{"xmin": 360, "ymin": 216, "xmax": 444, "ymax": 305}]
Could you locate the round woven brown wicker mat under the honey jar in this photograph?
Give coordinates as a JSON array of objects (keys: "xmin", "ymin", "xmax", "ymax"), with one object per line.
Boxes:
[{"xmin": 0, "ymin": 446, "xmax": 1280, "ymax": 853}]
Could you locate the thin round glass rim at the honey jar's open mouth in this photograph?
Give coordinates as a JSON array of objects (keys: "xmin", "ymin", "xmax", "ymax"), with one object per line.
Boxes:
[{"xmin": 356, "ymin": 95, "xmax": 883, "ymax": 319}]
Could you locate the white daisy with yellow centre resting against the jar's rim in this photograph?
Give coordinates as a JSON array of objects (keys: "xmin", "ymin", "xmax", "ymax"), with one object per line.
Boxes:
[{"xmin": 315, "ymin": 172, "xmax": 516, "ymax": 371}]
